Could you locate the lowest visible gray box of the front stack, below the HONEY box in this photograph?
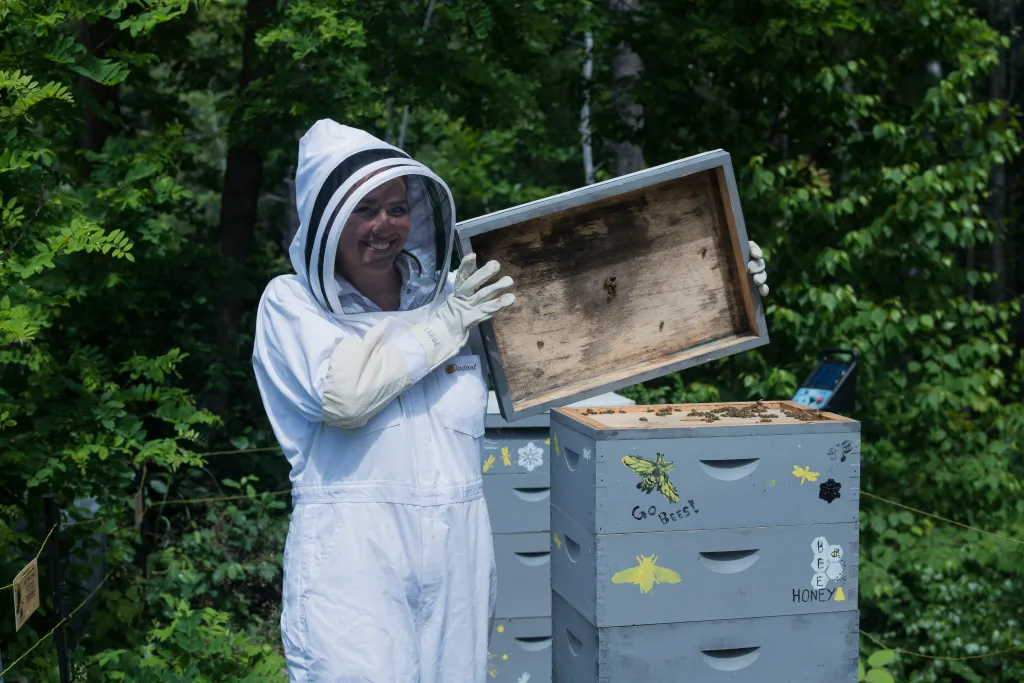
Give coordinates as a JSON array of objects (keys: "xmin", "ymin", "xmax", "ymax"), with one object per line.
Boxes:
[{"xmin": 553, "ymin": 595, "xmax": 859, "ymax": 683}]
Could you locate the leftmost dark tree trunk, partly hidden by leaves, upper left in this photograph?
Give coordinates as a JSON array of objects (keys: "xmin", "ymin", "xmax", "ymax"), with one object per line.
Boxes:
[{"xmin": 78, "ymin": 17, "xmax": 120, "ymax": 176}]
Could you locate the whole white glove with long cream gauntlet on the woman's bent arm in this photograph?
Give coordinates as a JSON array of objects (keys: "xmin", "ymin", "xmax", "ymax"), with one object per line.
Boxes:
[{"xmin": 323, "ymin": 254, "xmax": 515, "ymax": 429}]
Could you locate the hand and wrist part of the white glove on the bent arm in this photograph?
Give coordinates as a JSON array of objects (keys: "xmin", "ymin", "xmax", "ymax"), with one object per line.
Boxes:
[{"xmin": 412, "ymin": 254, "xmax": 515, "ymax": 370}]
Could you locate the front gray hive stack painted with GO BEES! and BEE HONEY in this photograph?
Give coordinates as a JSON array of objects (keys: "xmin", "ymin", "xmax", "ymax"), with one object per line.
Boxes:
[{"xmin": 551, "ymin": 401, "xmax": 860, "ymax": 683}]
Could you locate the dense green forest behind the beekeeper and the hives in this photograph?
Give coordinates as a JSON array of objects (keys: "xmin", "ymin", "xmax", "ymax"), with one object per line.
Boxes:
[{"xmin": 0, "ymin": 0, "xmax": 1024, "ymax": 683}]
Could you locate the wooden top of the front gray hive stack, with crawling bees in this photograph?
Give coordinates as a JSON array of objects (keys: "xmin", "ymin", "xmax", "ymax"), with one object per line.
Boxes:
[{"xmin": 551, "ymin": 400, "xmax": 860, "ymax": 440}]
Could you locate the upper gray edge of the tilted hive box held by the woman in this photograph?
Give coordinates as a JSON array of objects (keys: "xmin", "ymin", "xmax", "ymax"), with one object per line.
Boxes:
[{"xmin": 455, "ymin": 150, "xmax": 731, "ymax": 240}]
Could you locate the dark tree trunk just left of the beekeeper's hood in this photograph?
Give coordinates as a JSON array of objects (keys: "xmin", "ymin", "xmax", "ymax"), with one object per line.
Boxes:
[{"xmin": 210, "ymin": 0, "xmax": 275, "ymax": 413}]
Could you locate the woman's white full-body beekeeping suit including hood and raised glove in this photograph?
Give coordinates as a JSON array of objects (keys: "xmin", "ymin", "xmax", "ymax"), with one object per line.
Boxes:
[{"xmin": 253, "ymin": 121, "xmax": 514, "ymax": 683}]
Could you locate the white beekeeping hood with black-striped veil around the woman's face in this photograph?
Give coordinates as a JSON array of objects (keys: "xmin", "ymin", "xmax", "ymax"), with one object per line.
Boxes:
[{"xmin": 289, "ymin": 119, "xmax": 455, "ymax": 317}]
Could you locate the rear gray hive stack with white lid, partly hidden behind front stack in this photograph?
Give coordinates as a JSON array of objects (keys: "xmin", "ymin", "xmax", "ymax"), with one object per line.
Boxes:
[{"xmin": 483, "ymin": 393, "xmax": 633, "ymax": 683}]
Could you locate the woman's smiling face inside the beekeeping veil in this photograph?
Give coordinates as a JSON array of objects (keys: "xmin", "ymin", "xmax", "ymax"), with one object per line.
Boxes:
[{"xmin": 338, "ymin": 178, "xmax": 410, "ymax": 275}]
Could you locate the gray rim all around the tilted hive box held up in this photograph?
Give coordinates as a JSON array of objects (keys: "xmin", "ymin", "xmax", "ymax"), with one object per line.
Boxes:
[{"xmin": 456, "ymin": 150, "xmax": 768, "ymax": 426}]
